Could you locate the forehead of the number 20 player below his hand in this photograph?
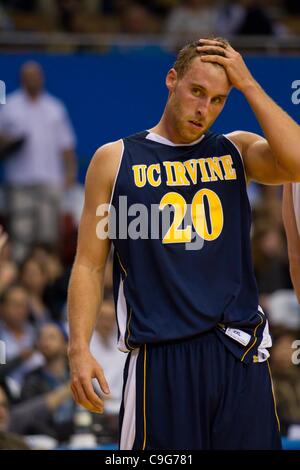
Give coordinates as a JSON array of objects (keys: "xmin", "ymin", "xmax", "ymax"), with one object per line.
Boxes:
[{"xmin": 182, "ymin": 57, "xmax": 231, "ymax": 95}]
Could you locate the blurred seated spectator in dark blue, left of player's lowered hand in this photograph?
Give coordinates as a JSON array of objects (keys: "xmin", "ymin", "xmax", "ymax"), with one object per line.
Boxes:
[{"xmin": 21, "ymin": 323, "xmax": 74, "ymax": 440}]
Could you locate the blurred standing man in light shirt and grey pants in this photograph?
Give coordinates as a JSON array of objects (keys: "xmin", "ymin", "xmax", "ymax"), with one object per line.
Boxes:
[{"xmin": 0, "ymin": 62, "xmax": 76, "ymax": 262}]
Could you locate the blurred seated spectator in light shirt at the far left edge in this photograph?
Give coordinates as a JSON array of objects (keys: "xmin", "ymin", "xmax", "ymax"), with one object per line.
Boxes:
[{"xmin": 0, "ymin": 284, "xmax": 42, "ymax": 399}]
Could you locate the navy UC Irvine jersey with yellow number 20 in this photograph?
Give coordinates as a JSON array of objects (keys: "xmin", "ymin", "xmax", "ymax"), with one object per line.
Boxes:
[{"xmin": 111, "ymin": 131, "xmax": 266, "ymax": 360}]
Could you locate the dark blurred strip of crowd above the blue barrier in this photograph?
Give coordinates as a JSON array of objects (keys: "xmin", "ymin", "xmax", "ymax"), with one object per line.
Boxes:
[{"xmin": 0, "ymin": 0, "xmax": 300, "ymax": 38}]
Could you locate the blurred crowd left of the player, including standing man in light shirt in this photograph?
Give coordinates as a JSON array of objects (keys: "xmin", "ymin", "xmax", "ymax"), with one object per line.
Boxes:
[{"xmin": 0, "ymin": 62, "xmax": 126, "ymax": 449}]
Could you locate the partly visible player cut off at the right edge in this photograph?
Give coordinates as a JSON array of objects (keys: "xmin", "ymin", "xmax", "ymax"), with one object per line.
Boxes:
[{"xmin": 282, "ymin": 183, "xmax": 300, "ymax": 304}]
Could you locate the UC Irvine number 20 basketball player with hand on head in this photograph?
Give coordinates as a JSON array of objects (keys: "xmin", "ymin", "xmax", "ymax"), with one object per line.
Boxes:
[{"xmin": 69, "ymin": 39, "xmax": 300, "ymax": 450}]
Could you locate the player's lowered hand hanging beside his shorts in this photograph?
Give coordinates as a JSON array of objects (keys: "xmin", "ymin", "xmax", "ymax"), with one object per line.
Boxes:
[{"xmin": 69, "ymin": 350, "xmax": 110, "ymax": 413}]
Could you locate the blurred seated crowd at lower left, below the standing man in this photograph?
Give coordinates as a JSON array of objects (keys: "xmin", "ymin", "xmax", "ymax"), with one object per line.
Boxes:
[{"xmin": 0, "ymin": 233, "xmax": 119, "ymax": 449}]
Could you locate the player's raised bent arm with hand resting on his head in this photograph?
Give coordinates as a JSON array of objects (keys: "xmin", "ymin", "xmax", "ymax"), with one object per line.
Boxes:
[{"xmin": 199, "ymin": 40, "xmax": 300, "ymax": 184}]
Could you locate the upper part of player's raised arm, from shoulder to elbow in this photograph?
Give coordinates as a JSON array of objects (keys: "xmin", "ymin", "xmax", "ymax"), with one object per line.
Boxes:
[{"xmin": 228, "ymin": 131, "xmax": 299, "ymax": 184}]
